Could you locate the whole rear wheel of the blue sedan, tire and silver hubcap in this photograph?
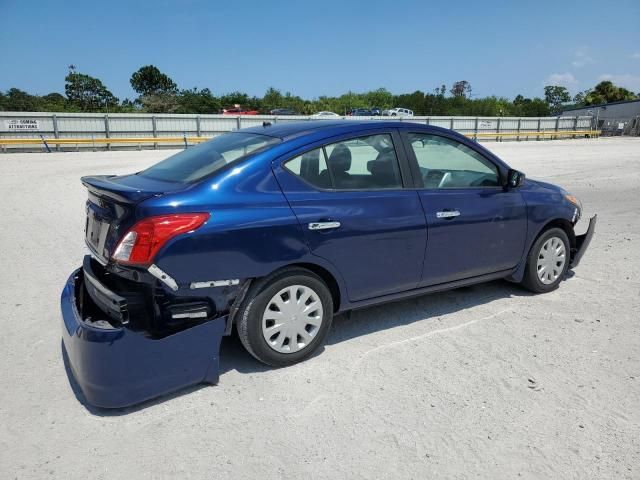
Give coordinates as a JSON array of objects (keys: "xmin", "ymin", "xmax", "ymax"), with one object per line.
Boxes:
[{"xmin": 237, "ymin": 268, "xmax": 333, "ymax": 367}]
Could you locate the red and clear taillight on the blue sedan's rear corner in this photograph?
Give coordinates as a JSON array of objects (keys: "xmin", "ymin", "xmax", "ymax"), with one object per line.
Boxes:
[{"xmin": 112, "ymin": 213, "xmax": 210, "ymax": 266}]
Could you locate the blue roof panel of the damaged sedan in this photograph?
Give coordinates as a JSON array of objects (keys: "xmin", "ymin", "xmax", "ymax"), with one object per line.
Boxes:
[{"xmin": 239, "ymin": 120, "xmax": 455, "ymax": 140}]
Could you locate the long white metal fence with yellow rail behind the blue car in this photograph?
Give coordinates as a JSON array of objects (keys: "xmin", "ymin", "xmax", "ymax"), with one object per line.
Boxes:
[{"xmin": 0, "ymin": 112, "xmax": 596, "ymax": 152}]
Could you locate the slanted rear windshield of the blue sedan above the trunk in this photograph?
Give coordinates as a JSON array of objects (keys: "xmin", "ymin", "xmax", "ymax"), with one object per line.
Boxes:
[{"xmin": 138, "ymin": 132, "xmax": 281, "ymax": 183}]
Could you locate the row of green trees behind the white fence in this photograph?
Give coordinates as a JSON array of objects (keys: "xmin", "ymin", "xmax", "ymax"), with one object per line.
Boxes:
[{"xmin": 0, "ymin": 65, "xmax": 640, "ymax": 117}]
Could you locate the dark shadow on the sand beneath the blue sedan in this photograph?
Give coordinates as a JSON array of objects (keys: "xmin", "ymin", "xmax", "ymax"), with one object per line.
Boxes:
[{"xmin": 62, "ymin": 280, "xmax": 533, "ymax": 417}]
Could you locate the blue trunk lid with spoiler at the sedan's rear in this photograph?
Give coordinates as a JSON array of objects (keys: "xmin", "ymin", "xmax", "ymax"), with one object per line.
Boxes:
[{"xmin": 81, "ymin": 174, "xmax": 184, "ymax": 264}]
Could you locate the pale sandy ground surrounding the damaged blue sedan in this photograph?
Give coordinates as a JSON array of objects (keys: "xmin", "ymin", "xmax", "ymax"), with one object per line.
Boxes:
[{"xmin": 0, "ymin": 139, "xmax": 640, "ymax": 480}]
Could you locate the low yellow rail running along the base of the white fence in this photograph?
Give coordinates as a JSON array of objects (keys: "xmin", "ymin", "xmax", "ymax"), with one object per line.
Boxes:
[{"xmin": 0, "ymin": 130, "xmax": 600, "ymax": 145}]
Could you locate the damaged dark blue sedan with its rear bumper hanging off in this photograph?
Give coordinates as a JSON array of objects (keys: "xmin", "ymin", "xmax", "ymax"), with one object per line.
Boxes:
[{"xmin": 61, "ymin": 120, "xmax": 596, "ymax": 407}]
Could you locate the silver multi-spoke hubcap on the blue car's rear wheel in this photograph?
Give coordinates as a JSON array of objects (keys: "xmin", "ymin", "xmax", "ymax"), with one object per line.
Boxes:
[{"xmin": 262, "ymin": 285, "xmax": 323, "ymax": 353}]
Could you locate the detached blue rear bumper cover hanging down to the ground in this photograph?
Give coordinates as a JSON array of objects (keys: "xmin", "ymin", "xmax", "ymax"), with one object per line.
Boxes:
[{"xmin": 61, "ymin": 269, "xmax": 225, "ymax": 408}]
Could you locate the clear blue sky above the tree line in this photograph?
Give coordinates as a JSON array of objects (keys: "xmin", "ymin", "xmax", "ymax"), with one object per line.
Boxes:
[{"xmin": 0, "ymin": 0, "xmax": 640, "ymax": 99}]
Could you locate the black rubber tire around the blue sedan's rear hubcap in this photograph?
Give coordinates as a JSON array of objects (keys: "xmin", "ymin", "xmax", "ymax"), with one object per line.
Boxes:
[{"xmin": 236, "ymin": 267, "xmax": 333, "ymax": 367}]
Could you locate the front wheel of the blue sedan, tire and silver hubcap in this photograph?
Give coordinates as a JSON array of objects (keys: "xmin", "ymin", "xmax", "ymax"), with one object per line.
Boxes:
[{"xmin": 522, "ymin": 228, "xmax": 570, "ymax": 293}]
